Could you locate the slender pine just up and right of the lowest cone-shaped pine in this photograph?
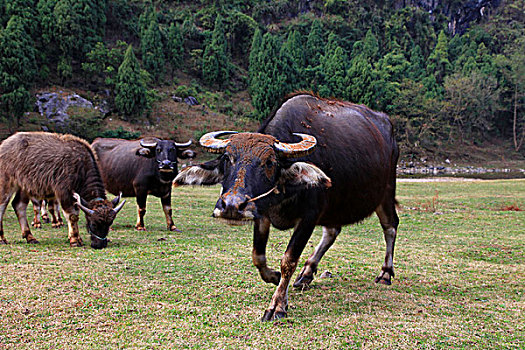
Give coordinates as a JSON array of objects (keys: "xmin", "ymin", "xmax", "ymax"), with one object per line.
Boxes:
[{"xmin": 140, "ymin": 14, "xmax": 165, "ymax": 80}]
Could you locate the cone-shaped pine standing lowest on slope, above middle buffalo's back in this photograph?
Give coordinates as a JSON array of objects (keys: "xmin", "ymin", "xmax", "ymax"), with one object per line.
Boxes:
[{"xmin": 115, "ymin": 45, "xmax": 149, "ymax": 118}]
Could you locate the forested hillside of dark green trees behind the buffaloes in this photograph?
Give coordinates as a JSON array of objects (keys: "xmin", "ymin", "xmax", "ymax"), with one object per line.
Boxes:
[{"xmin": 0, "ymin": 0, "xmax": 525, "ymax": 160}]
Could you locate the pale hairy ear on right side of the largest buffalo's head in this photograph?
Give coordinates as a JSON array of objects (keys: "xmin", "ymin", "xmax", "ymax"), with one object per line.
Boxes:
[{"xmin": 279, "ymin": 162, "xmax": 332, "ymax": 188}]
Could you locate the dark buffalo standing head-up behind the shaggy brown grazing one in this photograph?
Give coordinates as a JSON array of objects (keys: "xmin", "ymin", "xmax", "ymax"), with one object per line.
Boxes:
[{"xmin": 91, "ymin": 138, "xmax": 195, "ymax": 231}]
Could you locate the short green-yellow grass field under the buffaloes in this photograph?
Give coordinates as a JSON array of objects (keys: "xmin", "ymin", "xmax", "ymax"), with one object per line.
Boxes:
[{"xmin": 0, "ymin": 180, "xmax": 525, "ymax": 349}]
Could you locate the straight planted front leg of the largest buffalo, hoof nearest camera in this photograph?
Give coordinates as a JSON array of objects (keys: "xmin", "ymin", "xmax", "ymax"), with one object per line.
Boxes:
[{"xmin": 262, "ymin": 219, "xmax": 315, "ymax": 321}]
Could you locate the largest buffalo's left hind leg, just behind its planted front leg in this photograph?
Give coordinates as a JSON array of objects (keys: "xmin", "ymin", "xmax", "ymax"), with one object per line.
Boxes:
[{"xmin": 293, "ymin": 226, "xmax": 341, "ymax": 288}]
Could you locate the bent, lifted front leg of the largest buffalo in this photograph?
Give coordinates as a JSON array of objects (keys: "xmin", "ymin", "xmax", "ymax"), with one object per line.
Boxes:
[{"xmin": 252, "ymin": 217, "xmax": 281, "ymax": 285}]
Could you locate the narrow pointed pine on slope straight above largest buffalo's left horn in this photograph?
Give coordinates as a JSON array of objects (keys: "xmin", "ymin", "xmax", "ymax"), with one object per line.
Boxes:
[{"xmin": 202, "ymin": 15, "xmax": 231, "ymax": 87}]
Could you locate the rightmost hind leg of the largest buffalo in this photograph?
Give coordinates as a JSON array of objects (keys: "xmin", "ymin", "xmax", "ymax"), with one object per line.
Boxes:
[{"xmin": 375, "ymin": 196, "xmax": 399, "ymax": 285}]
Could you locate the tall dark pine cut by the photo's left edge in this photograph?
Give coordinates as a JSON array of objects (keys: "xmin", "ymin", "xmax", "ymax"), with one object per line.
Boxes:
[{"xmin": 0, "ymin": 15, "xmax": 36, "ymax": 125}]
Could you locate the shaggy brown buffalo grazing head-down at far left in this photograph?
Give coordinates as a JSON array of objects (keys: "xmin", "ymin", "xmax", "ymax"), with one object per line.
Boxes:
[{"xmin": 0, "ymin": 132, "xmax": 125, "ymax": 249}]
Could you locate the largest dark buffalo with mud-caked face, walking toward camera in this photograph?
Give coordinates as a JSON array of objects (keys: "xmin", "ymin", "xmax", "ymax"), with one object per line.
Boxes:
[{"xmin": 175, "ymin": 93, "xmax": 399, "ymax": 321}]
